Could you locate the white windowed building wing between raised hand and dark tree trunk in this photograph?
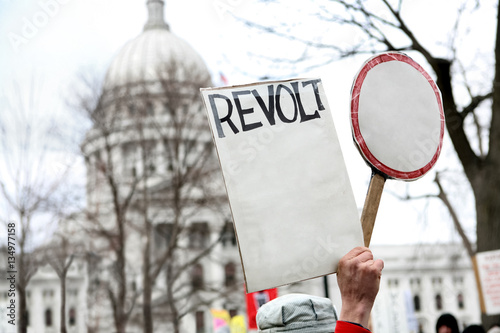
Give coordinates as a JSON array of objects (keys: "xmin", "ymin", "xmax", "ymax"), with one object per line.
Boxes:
[{"xmin": 372, "ymin": 244, "xmax": 481, "ymax": 333}]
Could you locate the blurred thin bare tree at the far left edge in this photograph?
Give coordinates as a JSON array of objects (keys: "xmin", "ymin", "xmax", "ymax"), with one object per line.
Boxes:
[{"xmin": 0, "ymin": 77, "xmax": 76, "ymax": 333}]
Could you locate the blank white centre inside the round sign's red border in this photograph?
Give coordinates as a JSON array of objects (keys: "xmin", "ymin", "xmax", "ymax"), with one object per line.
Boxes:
[{"xmin": 358, "ymin": 61, "xmax": 442, "ymax": 172}]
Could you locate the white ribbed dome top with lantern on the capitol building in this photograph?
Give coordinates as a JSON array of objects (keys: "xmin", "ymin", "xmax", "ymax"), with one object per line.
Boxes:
[{"xmin": 104, "ymin": 0, "xmax": 210, "ymax": 89}]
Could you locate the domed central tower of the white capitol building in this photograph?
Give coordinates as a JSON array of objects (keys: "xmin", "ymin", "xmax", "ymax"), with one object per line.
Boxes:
[{"xmin": 82, "ymin": 0, "xmax": 244, "ymax": 332}]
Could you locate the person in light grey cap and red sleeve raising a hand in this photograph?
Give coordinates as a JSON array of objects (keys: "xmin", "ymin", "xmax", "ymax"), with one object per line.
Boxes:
[{"xmin": 257, "ymin": 247, "xmax": 384, "ymax": 333}]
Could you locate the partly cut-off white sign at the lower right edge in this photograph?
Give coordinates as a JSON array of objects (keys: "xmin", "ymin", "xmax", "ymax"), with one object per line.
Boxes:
[{"xmin": 476, "ymin": 250, "xmax": 500, "ymax": 316}]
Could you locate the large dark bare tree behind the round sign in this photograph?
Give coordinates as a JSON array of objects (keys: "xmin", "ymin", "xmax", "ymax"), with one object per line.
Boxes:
[{"xmin": 235, "ymin": 0, "xmax": 500, "ymax": 326}]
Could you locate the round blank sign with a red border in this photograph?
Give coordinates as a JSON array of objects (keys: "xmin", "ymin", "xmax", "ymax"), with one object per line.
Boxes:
[{"xmin": 351, "ymin": 52, "xmax": 444, "ymax": 180}]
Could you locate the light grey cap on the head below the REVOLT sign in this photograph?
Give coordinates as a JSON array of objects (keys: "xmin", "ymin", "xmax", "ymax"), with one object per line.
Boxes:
[{"xmin": 256, "ymin": 294, "xmax": 337, "ymax": 333}]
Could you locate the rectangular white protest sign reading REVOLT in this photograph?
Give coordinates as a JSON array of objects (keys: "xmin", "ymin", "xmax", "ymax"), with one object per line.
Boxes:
[{"xmin": 201, "ymin": 79, "xmax": 363, "ymax": 292}]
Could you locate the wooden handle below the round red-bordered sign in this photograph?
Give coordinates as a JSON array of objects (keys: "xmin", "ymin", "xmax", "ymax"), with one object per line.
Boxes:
[{"xmin": 361, "ymin": 172, "xmax": 385, "ymax": 247}]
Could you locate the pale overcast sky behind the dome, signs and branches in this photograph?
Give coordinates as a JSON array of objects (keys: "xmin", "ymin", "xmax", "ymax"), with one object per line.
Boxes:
[{"xmin": 0, "ymin": 0, "xmax": 496, "ymax": 244}]
